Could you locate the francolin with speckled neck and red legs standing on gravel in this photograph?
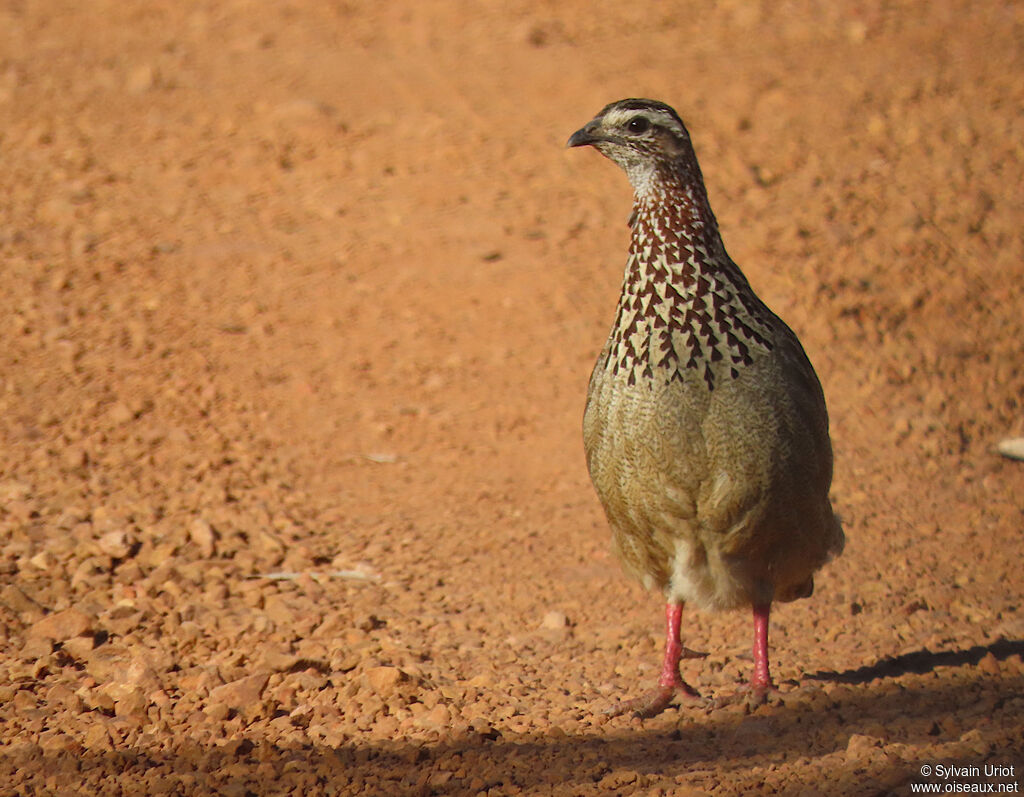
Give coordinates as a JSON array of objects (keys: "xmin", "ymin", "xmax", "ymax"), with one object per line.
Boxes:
[{"xmin": 567, "ymin": 98, "xmax": 845, "ymax": 718}]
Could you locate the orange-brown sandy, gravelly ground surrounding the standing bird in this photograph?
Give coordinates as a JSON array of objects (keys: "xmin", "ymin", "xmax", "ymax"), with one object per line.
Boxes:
[{"xmin": 0, "ymin": 0, "xmax": 1024, "ymax": 797}]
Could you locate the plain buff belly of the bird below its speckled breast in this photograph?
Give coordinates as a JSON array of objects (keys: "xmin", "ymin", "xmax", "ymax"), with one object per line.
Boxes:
[{"xmin": 584, "ymin": 358, "xmax": 838, "ymax": 609}]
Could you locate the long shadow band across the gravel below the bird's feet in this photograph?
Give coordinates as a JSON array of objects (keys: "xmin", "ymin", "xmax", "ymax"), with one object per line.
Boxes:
[{"xmin": 0, "ymin": 640, "xmax": 1024, "ymax": 797}]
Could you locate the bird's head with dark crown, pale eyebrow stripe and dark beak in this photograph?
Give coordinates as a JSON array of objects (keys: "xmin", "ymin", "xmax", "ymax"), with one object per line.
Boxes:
[{"xmin": 568, "ymin": 99, "xmax": 699, "ymax": 196}]
